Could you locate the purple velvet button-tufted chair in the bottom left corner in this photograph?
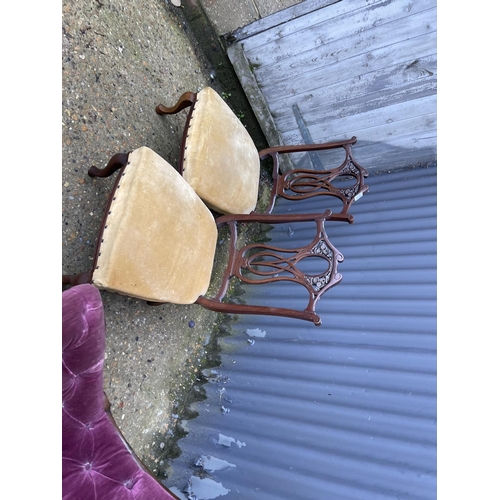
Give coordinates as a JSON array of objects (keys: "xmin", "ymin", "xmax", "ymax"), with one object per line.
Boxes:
[{"xmin": 62, "ymin": 284, "xmax": 178, "ymax": 500}]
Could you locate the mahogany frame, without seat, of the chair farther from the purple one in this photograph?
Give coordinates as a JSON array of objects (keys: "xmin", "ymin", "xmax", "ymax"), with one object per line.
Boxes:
[{"xmin": 155, "ymin": 92, "xmax": 368, "ymax": 224}]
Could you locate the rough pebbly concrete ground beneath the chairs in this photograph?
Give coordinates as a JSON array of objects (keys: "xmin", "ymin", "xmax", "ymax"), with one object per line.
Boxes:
[{"xmin": 62, "ymin": 0, "xmax": 297, "ymax": 476}]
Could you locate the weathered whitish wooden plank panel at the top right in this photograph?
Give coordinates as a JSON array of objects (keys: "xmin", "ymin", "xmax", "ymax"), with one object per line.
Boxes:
[{"xmin": 228, "ymin": 0, "xmax": 437, "ymax": 170}]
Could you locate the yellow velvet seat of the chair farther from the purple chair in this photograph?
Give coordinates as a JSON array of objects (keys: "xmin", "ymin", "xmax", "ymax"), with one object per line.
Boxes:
[{"xmin": 181, "ymin": 87, "xmax": 260, "ymax": 214}]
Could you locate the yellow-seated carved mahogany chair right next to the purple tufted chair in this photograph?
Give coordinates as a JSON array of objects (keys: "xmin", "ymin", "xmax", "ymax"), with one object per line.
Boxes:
[{"xmin": 63, "ymin": 147, "xmax": 347, "ymax": 325}]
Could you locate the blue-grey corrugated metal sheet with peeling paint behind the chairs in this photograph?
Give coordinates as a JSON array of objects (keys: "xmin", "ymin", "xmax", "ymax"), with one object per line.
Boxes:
[{"xmin": 167, "ymin": 165, "xmax": 436, "ymax": 500}]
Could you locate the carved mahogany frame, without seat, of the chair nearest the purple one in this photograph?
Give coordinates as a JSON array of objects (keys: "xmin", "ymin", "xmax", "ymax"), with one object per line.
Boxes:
[{"xmin": 62, "ymin": 153, "xmax": 348, "ymax": 326}]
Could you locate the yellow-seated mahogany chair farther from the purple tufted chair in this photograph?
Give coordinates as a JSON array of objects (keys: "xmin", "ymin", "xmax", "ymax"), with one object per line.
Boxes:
[{"xmin": 156, "ymin": 87, "xmax": 368, "ymax": 223}]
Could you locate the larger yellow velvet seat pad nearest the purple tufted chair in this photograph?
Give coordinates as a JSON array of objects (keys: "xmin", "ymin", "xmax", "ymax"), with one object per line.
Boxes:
[{"xmin": 92, "ymin": 147, "xmax": 217, "ymax": 304}]
